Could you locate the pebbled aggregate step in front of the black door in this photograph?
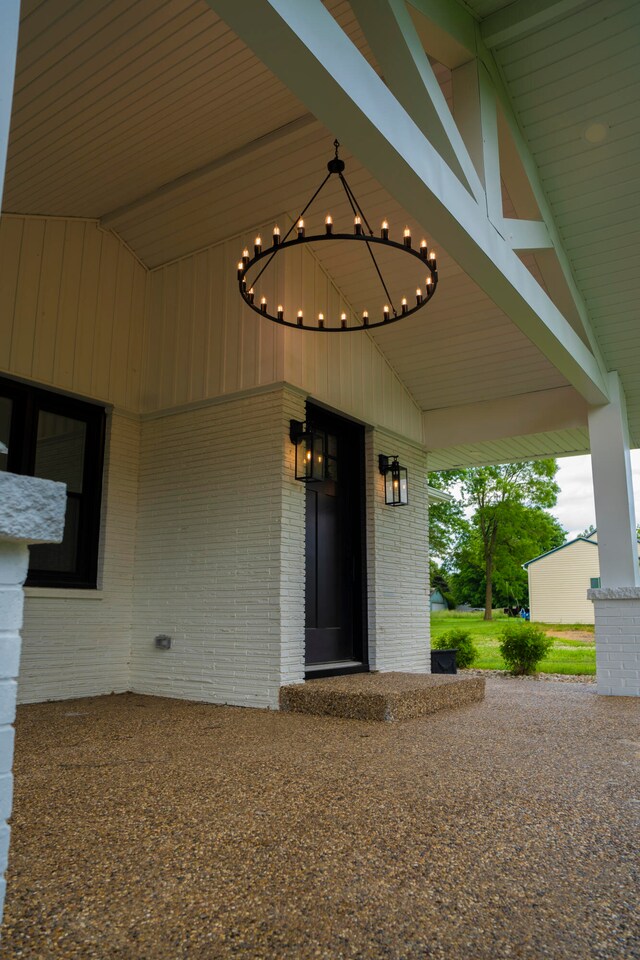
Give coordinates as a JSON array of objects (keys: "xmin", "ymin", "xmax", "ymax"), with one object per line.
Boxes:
[{"xmin": 280, "ymin": 673, "xmax": 485, "ymax": 721}]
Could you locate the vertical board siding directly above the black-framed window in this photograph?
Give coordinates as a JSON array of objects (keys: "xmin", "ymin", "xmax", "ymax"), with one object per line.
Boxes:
[{"xmin": 0, "ymin": 214, "xmax": 148, "ymax": 411}]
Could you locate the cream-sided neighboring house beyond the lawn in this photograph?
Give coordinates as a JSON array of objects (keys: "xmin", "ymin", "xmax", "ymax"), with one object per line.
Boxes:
[{"xmin": 523, "ymin": 530, "xmax": 640, "ymax": 623}]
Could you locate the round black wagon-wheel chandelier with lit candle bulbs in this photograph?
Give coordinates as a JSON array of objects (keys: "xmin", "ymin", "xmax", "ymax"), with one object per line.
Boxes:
[{"xmin": 238, "ymin": 140, "xmax": 438, "ymax": 333}]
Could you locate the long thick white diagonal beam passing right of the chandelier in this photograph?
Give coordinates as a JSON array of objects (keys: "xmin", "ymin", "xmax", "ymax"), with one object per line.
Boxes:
[{"xmin": 208, "ymin": 0, "xmax": 607, "ymax": 404}]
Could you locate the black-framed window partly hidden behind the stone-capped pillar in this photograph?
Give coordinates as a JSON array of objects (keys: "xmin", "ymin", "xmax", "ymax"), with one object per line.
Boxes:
[{"xmin": 0, "ymin": 377, "xmax": 105, "ymax": 588}]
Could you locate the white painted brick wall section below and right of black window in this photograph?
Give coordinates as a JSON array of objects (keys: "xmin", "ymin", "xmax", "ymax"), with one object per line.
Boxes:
[{"xmin": 18, "ymin": 415, "xmax": 140, "ymax": 703}]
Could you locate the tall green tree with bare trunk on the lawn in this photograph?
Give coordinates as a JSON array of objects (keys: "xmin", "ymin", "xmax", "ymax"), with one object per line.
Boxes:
[{"xmin": 459, "ymin": 460, "xmax": 559, "ymax": 620}]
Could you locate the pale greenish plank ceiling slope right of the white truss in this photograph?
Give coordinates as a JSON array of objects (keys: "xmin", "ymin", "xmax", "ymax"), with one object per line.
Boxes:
[{"xmin": 478, "ymin": 0, "xmax": 640, "ymax": 445}]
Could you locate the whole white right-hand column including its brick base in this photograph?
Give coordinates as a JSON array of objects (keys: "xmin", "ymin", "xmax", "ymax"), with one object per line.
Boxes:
[{"xmin": 588, "ymin": 373, "xmax": 640, "ymax": 697}]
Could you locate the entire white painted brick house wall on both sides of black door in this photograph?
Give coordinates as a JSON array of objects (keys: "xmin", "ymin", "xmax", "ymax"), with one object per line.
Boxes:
[{"xmin": 15, "ymin": 387, "xmax": 436, "ymax": 707}]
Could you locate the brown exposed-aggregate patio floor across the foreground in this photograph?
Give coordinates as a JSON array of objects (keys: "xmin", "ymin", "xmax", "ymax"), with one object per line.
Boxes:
[{"xmin": 2, "ymin": 679, "xmax": 640, "ymax": 960}]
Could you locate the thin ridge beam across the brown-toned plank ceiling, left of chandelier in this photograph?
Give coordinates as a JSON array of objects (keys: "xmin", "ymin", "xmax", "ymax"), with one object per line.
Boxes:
[{"xmin": 100, "ymin": 113, "xmax": 318, "ymax": 229}]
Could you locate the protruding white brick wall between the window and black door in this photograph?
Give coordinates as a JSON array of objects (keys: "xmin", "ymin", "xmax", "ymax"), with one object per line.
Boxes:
[{"xmin": 131, "ymin": 389, "xmax": 304, "ymax": 707}]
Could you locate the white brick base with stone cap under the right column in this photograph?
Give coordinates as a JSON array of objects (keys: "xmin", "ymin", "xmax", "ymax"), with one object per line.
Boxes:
[{"xmin": 589, "ymin": 588, "xmax": 640, "ymax": 697}]
